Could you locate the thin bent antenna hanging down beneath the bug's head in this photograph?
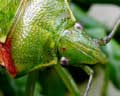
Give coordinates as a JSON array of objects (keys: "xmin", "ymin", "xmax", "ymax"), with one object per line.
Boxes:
[{"xmin": 81, "ymin": 65, "xmax": 94, "ymax": 96}]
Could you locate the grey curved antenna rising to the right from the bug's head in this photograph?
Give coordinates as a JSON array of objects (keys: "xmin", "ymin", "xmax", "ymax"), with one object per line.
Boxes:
[{"xmin": 97, "ymin": 19, "xmax": 120, "ymax": 46}]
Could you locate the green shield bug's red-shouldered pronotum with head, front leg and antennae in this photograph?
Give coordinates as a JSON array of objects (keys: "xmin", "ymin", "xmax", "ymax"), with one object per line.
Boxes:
[{"xmin": 0, "ymin": 0, "xmax": 119, "ymax": 96}]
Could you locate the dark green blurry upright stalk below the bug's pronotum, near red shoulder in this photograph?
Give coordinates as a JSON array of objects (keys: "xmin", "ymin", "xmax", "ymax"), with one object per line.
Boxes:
[{"xmin": 25, "ymin": 71, "xmax": 38, "ymax": 96}]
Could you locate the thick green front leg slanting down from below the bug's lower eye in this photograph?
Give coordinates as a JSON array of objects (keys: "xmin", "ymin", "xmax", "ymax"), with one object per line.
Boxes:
[{"xmin": 55, "ymin": 64, "xmax": 81, "ymax": 96}]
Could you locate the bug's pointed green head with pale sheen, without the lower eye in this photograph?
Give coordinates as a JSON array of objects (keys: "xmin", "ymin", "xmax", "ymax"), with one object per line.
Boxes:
[{"xmin": 58, "ymin": 23, "xmax": 106, "ymax": 64}]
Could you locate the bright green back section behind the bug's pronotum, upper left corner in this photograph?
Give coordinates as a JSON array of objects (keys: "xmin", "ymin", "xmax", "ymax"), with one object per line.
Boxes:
[{"xmin": 0, "ymin": 0, "xmax": 20, "ymax": 38}]
